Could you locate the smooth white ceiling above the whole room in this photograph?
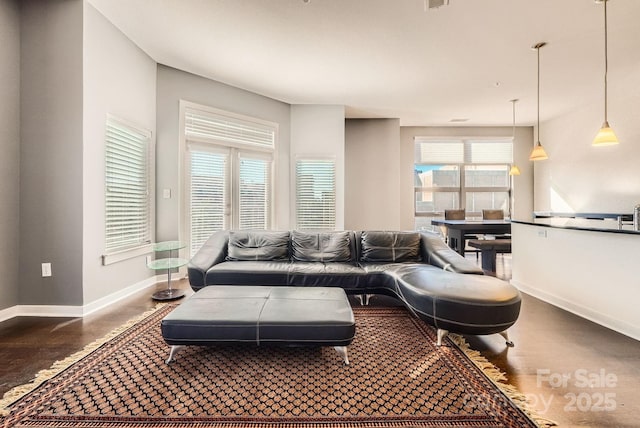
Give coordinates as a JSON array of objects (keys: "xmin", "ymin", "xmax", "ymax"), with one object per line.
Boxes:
[{"xmin": 89, "ymin": 0, "xmax": 640, "ymax": 127}]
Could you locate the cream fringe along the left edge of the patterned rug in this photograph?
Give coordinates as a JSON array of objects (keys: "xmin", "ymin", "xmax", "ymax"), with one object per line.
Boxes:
[{"xmin": 0, "ymin": 303, "xmax": 166, "ymax": 417}]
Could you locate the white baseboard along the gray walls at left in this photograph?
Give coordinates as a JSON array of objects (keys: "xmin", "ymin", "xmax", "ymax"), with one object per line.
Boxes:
[{"xmin": 0, "ymin": 275, "xmax": 166, "ymax": 322}]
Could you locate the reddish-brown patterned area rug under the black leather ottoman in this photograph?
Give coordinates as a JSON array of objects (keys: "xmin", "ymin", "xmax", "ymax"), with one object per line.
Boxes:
[{"xmin": 0, "ymin": 305, "xmax": 536, "ymax": 428}]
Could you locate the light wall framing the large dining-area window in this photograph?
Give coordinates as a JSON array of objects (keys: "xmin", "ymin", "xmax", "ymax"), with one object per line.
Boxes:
[{"xmin": 400, "ymin": 127, "xmax": 534, "ymax": 229}]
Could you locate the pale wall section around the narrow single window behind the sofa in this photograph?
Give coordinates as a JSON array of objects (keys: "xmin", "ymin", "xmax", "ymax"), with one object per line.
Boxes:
[{"xmin": 289, "ymin": 105, "xmax": 345, "ymax": 230}]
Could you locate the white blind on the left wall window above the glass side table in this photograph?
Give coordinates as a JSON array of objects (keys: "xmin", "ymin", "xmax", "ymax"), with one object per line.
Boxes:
[{"xmin": 105, "ymin": 117, "xmax": 151, "ymax": 253}]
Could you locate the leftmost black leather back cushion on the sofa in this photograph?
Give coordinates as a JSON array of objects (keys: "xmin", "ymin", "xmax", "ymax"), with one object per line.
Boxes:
[{"xmin": 227, "ymin": 230, "xmax": 289, "ymax": 261}]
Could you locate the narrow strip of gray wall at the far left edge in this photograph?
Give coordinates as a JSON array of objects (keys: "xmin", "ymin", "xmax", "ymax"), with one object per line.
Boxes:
[{"xmin": 0, "ymin": 0, "xmax": 20, "ymax": 310}]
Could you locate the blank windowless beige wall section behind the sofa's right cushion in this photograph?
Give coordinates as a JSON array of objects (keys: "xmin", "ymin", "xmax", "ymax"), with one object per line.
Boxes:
[{"xmin": 345, "ymin": 119, "xmax": 401, "ymax": 230}]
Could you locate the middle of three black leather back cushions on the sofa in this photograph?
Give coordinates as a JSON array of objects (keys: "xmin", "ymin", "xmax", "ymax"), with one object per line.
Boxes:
[{"xmin": 291, "ymin": 231, "xmax": 351, "ymax": 262}]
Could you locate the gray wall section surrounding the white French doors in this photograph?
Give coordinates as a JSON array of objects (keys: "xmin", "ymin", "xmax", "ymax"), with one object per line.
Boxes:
[{"xmin": 156, "ymin": 65, "xmax": 291, "ymax": 241}]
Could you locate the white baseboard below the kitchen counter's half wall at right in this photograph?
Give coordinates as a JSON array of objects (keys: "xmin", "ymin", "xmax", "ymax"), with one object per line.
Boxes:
[{"xmin": 511, "ymin": 280, "xmax": 640, "ymax": 340}]
